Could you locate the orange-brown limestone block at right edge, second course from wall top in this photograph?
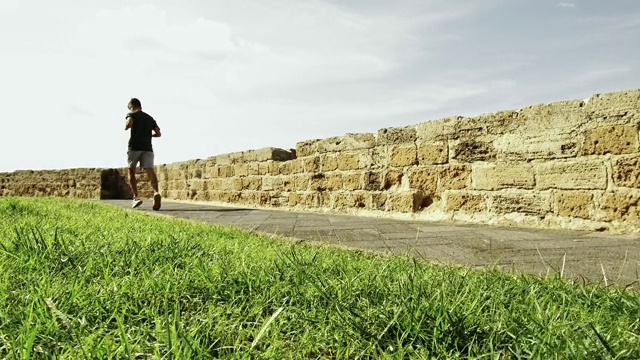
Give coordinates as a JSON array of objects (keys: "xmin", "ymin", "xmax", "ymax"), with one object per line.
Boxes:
[{"xmin": 582, "ymin": 125, "xmax": 638, "ymax": 155}]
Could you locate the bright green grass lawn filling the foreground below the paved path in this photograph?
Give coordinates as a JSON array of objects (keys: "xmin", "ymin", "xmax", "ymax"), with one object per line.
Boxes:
[{"xmin": 0, "ymin": 198, "xmax": 640, "ymax": 359}]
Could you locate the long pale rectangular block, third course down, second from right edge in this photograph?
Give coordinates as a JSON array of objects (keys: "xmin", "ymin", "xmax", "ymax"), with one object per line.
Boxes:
[{"xmin": 535, "ymin": 160, "xmax": 607, "ymax": 190}]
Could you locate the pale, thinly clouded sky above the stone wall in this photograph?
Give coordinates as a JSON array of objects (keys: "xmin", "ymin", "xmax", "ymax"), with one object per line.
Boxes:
[{"xmin": 0, "ymin": 0, "xmax": 640, "ymax": 172}]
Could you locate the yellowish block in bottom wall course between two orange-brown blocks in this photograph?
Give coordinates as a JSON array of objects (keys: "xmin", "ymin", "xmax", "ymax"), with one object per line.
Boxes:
[{"xmin": 491, "ymin": 192, "xmax": 551, "ymax": 215}]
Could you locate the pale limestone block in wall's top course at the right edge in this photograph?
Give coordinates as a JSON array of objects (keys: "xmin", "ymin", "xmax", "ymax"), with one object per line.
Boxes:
[{"xmin": 585, "ymin": 89, "xmax": 640, "ymax": 125}]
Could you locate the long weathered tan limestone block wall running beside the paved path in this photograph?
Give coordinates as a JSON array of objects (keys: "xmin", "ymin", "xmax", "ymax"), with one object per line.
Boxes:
[{"xmin": 0, "ymin": 89, "xmax": 640, "ymax": 232}]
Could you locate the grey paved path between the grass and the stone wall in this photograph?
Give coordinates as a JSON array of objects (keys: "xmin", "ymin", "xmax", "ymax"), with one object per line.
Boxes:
[{"xmin": 105, "ymin": 200, "xmax": 640, "ymax": 288}]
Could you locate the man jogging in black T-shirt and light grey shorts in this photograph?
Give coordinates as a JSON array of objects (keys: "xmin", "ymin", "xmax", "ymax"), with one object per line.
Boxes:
[{"xmin": 124, "ymin": 98, "xmax": 162, "ymax": 210}]
